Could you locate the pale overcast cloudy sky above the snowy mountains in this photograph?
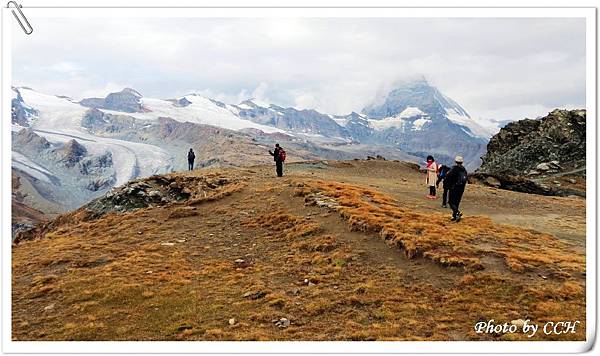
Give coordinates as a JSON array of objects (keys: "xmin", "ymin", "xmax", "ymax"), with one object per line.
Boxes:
[{"xmin": 13, "ymin": 18, "xmax": 585, "ymax": 120}]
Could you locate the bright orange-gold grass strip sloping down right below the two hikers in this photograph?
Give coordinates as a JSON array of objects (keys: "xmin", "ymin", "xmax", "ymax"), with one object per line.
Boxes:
[{"xmin": 295, "ymin": 180, "xmax": 585, "ymax": 276}]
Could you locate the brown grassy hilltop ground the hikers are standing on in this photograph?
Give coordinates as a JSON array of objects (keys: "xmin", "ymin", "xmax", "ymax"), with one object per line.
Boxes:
[{"xmin": 12, "ymin": 161, "xmax": 585, "ymax": 340}]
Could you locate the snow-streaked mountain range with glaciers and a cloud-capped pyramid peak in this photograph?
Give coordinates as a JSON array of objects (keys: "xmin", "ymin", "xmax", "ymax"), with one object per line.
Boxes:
[{"xmin": 12, "ymin": 79, "xmax": 498, "ymax": 217}]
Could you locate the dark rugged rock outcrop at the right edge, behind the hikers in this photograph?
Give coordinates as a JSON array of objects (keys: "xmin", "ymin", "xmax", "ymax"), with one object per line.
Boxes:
[{"xmin": 474, "ymin": 109, "xmax": 586, "ymax": 195}]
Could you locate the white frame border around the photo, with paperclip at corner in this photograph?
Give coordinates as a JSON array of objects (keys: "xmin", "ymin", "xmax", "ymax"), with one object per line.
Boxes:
[{"xmin": 0, "ymin": 1, "xmax": 597, "ymax": 353}]
